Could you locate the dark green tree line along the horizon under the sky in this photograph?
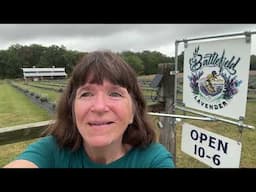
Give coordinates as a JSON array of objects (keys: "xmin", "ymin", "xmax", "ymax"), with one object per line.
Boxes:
[{"xmin": 0, "ymin": 44, "xmax": 256, "ymax": 79}]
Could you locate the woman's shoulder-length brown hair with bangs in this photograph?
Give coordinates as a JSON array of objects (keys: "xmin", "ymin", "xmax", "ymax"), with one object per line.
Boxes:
[{"xmin": 46, "ymin": 51, "xmax": 156, "ymax": 150}]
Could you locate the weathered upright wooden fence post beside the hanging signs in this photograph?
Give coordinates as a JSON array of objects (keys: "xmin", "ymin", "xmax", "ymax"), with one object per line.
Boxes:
[{"xmin": 158, "ymin": 63, "xmax": 176, "ymax": 163}]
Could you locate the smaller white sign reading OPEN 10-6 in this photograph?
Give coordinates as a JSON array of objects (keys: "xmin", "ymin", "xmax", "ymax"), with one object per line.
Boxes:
[{"xmin": 181, "ymin": 123, "xmax": 242, "ymax": 168}]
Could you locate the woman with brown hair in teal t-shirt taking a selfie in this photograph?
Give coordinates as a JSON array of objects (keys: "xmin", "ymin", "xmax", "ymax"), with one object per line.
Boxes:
[{"xmin": 5, "ymin": 51, "xmax": 174, "ymax": 168}]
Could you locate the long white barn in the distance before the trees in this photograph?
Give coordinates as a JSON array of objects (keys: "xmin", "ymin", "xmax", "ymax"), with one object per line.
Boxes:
[{"xmin": 22, "ymin": 67, "xmax": 67, "ymax": 81}]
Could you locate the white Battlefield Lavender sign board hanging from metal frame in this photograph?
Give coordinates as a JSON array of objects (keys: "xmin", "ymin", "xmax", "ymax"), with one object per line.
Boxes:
[{"xmin": 183, "ymin": 37, "xmax": 251, "ymax": 120}]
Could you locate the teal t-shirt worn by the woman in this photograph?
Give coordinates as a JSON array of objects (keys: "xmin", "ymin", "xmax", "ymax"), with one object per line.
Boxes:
[{"xmin": 17, "ymin": 136, "xmax": 175, "ymax": 168}]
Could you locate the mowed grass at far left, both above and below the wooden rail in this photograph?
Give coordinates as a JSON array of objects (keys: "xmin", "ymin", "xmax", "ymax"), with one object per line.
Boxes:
[{"xmin": 0, "ymin": 80, "xmax": 51, "ymax": 167}]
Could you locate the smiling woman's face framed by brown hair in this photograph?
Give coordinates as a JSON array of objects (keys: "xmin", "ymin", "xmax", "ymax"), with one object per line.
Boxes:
[{"xmin": 74, "ymin": 80, "xmax": 134, "ymax": 147}]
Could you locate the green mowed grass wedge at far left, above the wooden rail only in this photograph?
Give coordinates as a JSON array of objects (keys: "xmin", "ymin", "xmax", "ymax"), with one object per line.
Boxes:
[{"xmin": 0, "ymin": 80, "xmax": 51, "ymax": 128}]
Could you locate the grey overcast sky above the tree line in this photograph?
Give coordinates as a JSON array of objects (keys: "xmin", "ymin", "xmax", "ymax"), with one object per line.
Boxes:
[{"xmin": 0, "ymin": 24, "xmax": 256, "ymax": 56}]
